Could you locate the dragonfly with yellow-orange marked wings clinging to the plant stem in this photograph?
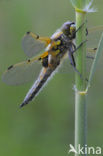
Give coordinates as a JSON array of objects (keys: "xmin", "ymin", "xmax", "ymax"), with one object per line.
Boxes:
[{"xmin": 2, "ymin": 21, "xmax": 103, "ymax": 107}]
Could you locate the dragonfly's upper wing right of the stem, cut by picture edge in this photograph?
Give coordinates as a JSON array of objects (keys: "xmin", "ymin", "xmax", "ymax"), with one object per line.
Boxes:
[{"xmin": 87, "ymin": 26, "xmax": 103, "ymax": 48}]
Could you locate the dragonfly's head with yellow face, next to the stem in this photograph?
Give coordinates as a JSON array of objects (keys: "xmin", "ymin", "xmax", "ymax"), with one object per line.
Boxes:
[{"xmin": 61, "ymin": 21, "xmax": 76, "ymax": 39}]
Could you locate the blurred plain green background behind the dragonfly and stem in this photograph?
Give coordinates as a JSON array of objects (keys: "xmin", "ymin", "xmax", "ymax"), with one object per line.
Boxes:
[{"xmin": 0, "ymin": 0, "xmax": 103, "ymax": 156}]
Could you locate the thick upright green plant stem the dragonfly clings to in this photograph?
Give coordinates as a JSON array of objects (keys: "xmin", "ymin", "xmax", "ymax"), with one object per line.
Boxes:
[{"xmin": 75, "ymin": 12, "xmax": 87, "ymax": 156}]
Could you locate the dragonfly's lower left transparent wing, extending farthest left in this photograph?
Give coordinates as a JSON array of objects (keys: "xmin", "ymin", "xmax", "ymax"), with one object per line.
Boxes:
[{"xmin": 2, "ymin": 57, "xmax": 42, "ymax": 85}]
